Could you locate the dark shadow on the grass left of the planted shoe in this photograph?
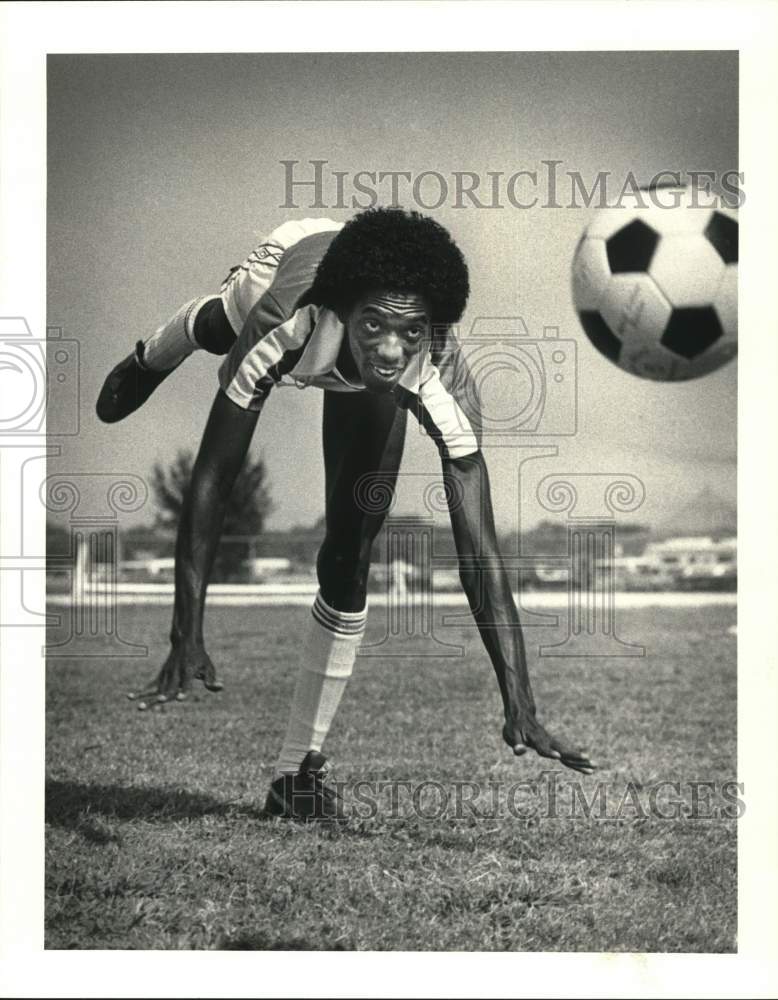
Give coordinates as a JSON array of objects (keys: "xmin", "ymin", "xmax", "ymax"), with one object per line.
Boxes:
[{"xmin": 46, "ymin": 780, "xmax": 259, "ymax": 831}]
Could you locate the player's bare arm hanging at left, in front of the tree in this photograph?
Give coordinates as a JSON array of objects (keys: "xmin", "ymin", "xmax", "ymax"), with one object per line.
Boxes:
[{"xmin": 130, "ymin": 390, "xmax": 259, "ymax": 709}]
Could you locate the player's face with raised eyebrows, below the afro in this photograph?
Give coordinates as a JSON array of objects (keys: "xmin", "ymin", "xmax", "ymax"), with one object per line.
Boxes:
[{"xmin": 343, "ymin": 291, "xmax": 430, "ymax": 393}]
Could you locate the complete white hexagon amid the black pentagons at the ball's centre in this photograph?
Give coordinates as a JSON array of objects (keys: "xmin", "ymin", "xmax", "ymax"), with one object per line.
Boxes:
[{"xmin": 650, "ymin": 235, "xmax": 724, "ymax": 307}]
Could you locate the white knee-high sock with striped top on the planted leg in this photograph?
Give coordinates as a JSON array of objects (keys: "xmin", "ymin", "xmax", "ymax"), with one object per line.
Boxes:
[{"xmin": 276, "ymin": 594, "xmax": 367, "ymax": 775}]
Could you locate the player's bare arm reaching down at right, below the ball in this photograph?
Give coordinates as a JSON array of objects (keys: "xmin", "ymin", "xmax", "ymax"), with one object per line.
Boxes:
[{"xmin": 443, "ymin": 451, "xmax": 594, "ymax": 774}]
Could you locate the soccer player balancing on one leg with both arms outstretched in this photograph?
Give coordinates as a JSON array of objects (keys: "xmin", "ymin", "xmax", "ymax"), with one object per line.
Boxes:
[{"xmin": 97, "ymin": 208, "xmax": 594, "ymax": 818}]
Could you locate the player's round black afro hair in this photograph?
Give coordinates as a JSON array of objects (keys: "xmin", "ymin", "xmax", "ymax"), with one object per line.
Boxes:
[{"xmin": 308, "ymin": 208, "xmax": 470, "ymax": 325}]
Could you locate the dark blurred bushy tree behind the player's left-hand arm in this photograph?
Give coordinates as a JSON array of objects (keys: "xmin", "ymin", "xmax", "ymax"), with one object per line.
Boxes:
[{"xmin": 151, "ymin": 449, "xmax": 273, "ymax": 581}]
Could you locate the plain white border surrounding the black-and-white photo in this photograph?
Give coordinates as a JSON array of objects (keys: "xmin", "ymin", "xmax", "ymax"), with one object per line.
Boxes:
[{"xmin": 0, "ymin": 0, "xmax": 778, "ymax": 997}]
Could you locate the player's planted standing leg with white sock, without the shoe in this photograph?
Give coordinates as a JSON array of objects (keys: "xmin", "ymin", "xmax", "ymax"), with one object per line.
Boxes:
[{"xmin": 276, "ymin": 392, "xmax": 406, "ymax": 775}]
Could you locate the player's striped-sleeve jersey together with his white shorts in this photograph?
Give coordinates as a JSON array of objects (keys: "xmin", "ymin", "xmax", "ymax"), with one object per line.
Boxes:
[{"xmin": 214, "ymin": 219, "xmax": 479, "ymax": 458}]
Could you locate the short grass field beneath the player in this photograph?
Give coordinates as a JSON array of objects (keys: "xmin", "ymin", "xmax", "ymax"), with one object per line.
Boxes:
[{"xmin": 46, "ymin": 607, "xmax": 737, "ymax": 952}]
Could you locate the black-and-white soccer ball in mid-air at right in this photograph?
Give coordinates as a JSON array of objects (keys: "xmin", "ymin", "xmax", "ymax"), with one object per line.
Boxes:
[{"xmin": 573, "ymin": 188, "xmax": 738, "ymax": 382}]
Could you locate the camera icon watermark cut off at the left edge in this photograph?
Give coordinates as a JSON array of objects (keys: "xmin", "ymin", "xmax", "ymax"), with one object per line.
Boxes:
[{"xmin": 0, "ymin": 316, "xmax": 80, "ymax": 436}]
